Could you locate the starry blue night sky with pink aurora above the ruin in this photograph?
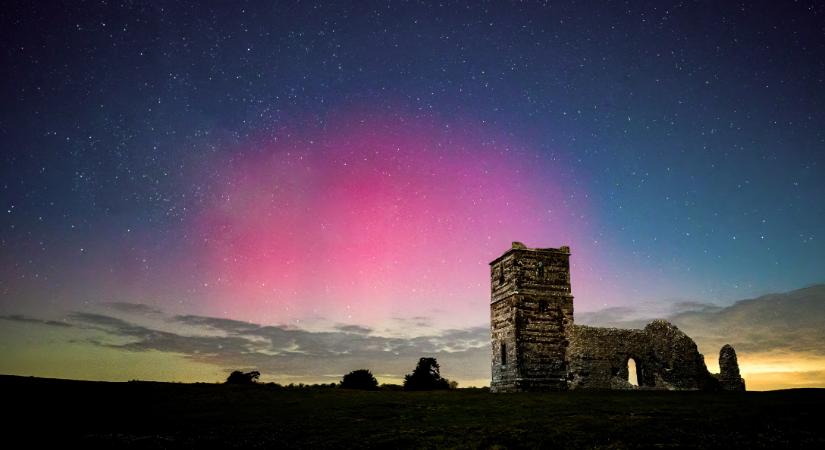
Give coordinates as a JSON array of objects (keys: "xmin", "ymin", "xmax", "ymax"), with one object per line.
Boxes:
[{"xmin": 0, "ymin": 1, "xmax": 825, "ymax": 384}]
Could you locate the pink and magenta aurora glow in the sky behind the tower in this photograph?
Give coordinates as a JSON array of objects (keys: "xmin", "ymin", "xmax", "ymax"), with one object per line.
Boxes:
[{"xmin": 196, "ymin": 113, "xmax": 588, "ymax": 325}]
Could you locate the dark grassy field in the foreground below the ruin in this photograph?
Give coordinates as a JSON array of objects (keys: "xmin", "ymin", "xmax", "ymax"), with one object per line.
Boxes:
[{"xmin": 0, "ymin": 376, "xmax": 825, "ymax": 448}]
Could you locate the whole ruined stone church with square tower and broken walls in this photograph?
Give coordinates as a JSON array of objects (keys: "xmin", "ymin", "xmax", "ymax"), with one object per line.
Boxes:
[{"xmin": 490, "ymin": 242, "xmax": 745, "ymax": 392}]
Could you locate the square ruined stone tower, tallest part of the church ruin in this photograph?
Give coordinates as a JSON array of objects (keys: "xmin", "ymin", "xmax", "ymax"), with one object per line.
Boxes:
[{"xmin": 490, "ymin": 242, "xmax": 573, "ymax": 392}]
